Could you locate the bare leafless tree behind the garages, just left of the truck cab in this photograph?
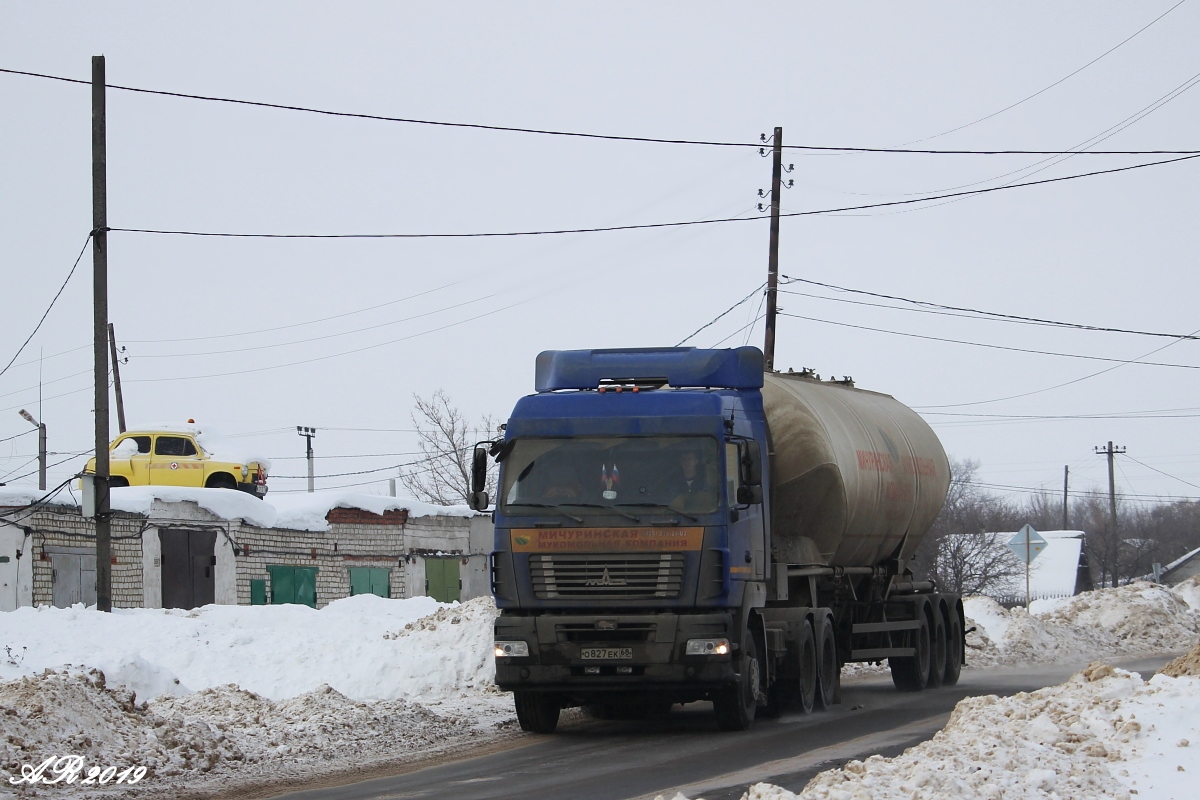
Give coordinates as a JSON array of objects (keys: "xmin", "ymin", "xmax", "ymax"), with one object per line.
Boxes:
[{"xmin": 400, "ymin": 389, "xmax": 496, "ymax": 505}]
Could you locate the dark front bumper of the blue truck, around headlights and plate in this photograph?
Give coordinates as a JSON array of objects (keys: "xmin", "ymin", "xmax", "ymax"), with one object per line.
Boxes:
[{"xmin": 496, "ymin": 612, "xmax": 737, "ymax": 702}]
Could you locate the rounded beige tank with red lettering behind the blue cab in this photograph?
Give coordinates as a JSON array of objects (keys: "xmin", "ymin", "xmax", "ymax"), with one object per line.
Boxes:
[{"xmin": 762, "ymin": 373, "xmax": 950, "ymax": 566}]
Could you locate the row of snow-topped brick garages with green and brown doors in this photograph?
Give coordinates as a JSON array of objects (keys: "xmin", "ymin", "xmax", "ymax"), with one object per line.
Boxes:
[{"xmin": 0, "ymin": 487, "xmax": 492, "ymax": 610}]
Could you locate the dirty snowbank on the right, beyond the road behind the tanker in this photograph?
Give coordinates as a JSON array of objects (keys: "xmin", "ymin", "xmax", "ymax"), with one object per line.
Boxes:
[{"xmin": 964, "ymin": 579, "xmax": 1200, "ymax": 667}]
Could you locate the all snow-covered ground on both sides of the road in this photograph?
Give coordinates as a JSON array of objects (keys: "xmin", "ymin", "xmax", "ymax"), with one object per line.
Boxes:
[{"xmin": 0, "ymin": 578, "xmax": 1200, "ymax": 800}]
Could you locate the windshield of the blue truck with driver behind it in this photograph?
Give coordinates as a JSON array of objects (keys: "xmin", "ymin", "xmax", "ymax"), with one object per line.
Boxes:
[{"xmin": 500, "ymin": 437, "xmax": 721, "ymax": 516}]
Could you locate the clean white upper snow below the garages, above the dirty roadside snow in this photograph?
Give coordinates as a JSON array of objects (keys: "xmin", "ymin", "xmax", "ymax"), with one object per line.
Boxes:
[{"xmin": 0, "ymin": 595, "xmax": 497, "ymax": 700}]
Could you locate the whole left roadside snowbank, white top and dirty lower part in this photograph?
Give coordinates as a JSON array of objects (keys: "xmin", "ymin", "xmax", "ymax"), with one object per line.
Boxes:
[{"xmin": 0, "ymin": 595, "xmax": 512, "ymax": 798}]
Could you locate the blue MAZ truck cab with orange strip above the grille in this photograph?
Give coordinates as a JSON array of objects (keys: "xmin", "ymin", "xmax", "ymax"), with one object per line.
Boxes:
[{"xmin": 485, "ymin": 347, "xmax": 770, "ymax": 730}]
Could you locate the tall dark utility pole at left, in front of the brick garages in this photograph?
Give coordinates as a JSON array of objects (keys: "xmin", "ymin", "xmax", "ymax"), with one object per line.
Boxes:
[{"xmin": 91, "ymin": 55, "xmax": 113, "ymax": 612}]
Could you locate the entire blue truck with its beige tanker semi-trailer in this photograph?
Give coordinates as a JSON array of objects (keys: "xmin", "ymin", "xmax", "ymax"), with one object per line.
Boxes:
[{"xmin": 472, "ymin": 347, "xmax": 964, "ymax": 733}]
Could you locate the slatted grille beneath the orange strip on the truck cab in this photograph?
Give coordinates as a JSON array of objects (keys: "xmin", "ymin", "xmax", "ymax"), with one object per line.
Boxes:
[{"xmin": 529, "ymin": 553, "xmax": 683, "ymax": 600}]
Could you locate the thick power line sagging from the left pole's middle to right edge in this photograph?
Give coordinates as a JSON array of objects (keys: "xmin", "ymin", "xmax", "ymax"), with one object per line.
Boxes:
[{"xmin": 100, "ymin": 154, "xmax": 1200, "ymax": 239}]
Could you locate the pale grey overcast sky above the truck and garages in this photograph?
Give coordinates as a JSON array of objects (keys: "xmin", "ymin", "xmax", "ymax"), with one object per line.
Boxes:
[{"xmin": 0, "ymin": 0, "xmax": 1200, "ymax": 513}]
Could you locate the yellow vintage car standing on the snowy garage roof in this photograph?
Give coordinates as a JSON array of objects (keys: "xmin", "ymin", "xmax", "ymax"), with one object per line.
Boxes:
[{"xmin": 84, "ymin": 425, "xmax": 270, "ymax": 498}]
